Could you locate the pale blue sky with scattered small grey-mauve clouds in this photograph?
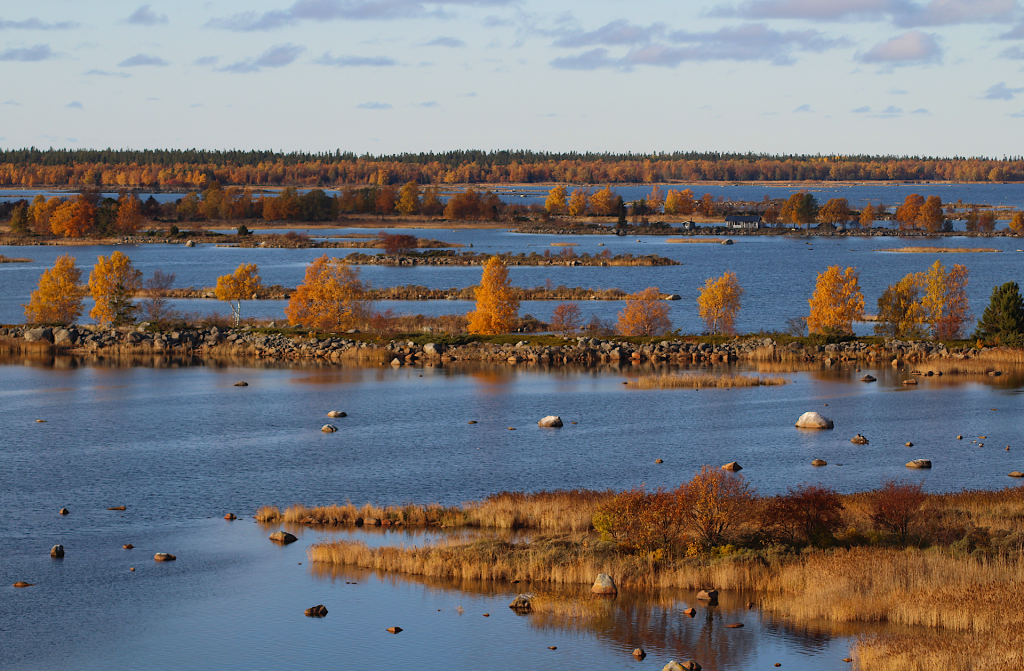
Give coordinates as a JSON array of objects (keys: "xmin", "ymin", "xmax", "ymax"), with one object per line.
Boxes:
[{"xmin": 0, "ymin": 0, "xmax": 1024, "ymax": 158}]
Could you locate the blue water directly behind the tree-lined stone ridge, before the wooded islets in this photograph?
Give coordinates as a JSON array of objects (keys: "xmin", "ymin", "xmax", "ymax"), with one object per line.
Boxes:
[{"xmin": 0, "ymin": 229, "xmax": 1024, "ymax": 333}]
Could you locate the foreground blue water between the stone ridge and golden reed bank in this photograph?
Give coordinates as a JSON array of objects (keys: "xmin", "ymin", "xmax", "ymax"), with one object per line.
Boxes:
[{"xmin": 0, "ymin": 360, "xmax": 1024, "ymax": 670}]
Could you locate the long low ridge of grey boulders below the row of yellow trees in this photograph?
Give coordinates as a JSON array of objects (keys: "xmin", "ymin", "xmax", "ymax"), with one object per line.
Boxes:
[{"xmin": 0, "ymin": 325, "xmax": 1011, "ymax": 375}]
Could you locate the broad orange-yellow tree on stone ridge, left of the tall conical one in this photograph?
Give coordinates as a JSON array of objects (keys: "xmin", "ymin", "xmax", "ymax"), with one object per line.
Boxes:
[{"xmin": 285, "ymin": 254, "xmax": 370, "ymax": 331}]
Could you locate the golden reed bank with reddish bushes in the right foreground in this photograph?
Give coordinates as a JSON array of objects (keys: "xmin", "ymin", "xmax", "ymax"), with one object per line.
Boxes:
[{"xmin": 272, "ymin": 483, "xmax": 1024, "ymax": 671}]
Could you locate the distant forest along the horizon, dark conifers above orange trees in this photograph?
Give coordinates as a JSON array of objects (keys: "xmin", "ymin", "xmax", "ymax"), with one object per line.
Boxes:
[{"xmin": 0, "ymin": 148, "xmax": 1024, "ymax": 190}]
